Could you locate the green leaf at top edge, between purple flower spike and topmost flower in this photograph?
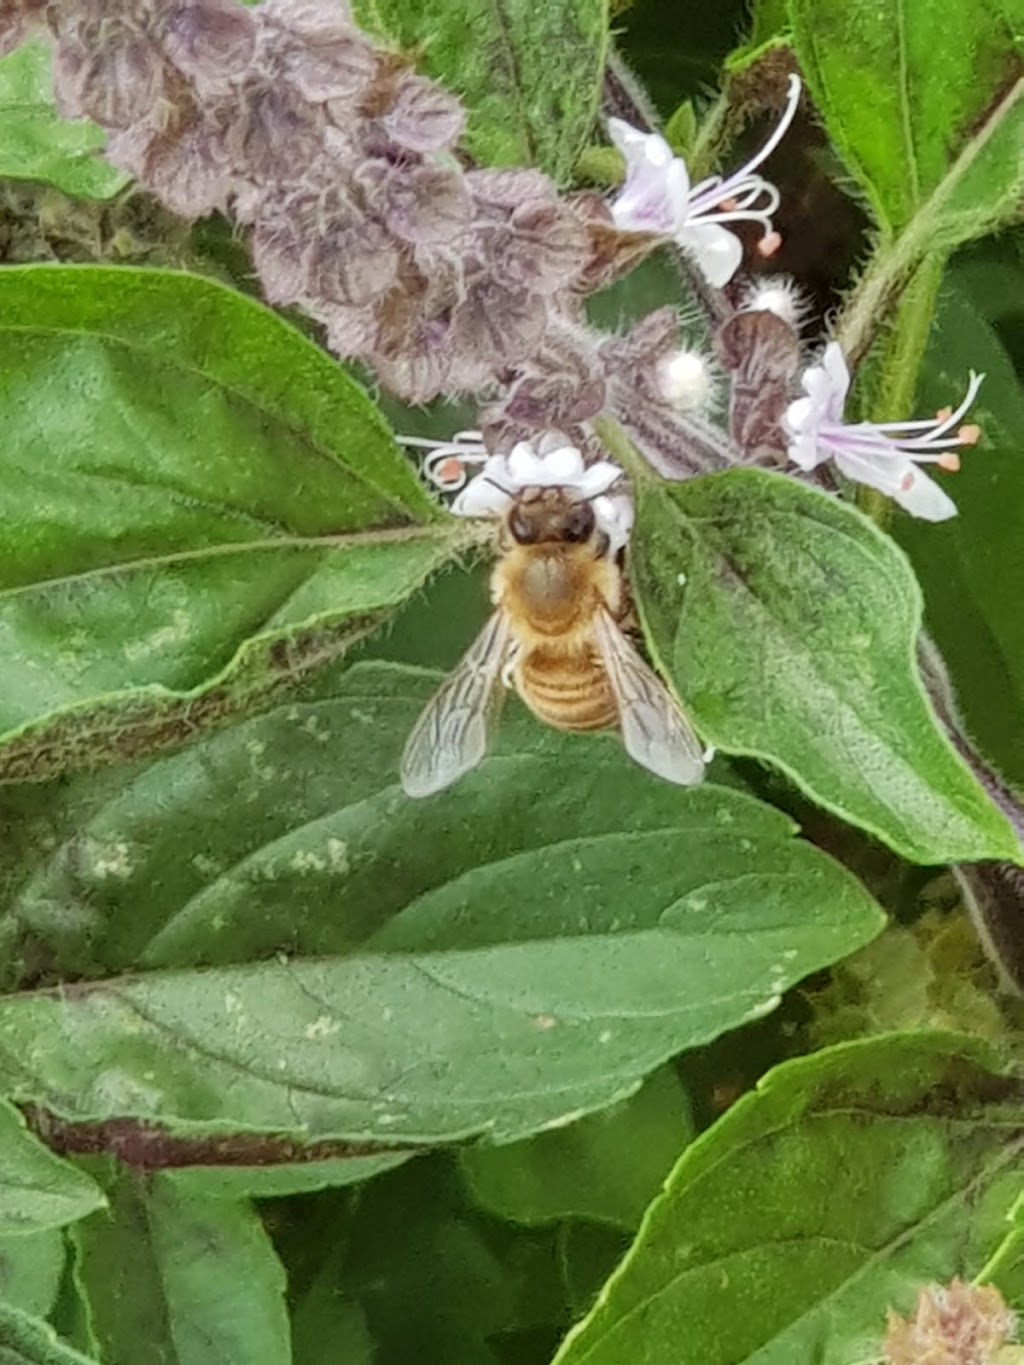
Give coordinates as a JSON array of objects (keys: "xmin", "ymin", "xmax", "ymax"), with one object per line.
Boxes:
[{"xmin": 354, "ymin": 0, "xmax": 609, "ymax": 184}]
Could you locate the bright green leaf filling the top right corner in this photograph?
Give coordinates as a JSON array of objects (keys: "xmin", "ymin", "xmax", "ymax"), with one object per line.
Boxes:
[{"xmin": 789, "ymin": 0, "xmax": 1024, "ymax": 247}]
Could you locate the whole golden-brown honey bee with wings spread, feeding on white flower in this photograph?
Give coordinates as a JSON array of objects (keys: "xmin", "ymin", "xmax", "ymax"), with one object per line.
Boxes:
[{"xmin": 401, "ymin": 486, "xmax": 705, "ymax": 797}]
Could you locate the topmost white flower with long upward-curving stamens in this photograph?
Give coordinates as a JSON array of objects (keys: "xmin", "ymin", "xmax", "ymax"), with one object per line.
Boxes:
[{"xmin": 608, "ymin": 75, "xmax": 800, "ymax": 289}]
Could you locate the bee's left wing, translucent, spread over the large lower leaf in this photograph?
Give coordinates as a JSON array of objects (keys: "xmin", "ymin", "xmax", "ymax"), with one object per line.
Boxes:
[{"xmin": 401, "ymin": 612, "xmax": 511, "ymax": 796}]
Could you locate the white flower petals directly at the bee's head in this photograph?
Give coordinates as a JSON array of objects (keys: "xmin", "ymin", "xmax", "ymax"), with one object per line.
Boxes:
[{"xmin": 452, "ymin": 437, "xmax": 632, "ymax": 550}]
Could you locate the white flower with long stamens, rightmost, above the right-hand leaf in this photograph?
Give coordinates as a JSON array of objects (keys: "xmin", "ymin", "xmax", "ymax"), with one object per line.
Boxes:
[{"xmin": 782, "ymin": 341, "xmax": 984, "ymax": 521}]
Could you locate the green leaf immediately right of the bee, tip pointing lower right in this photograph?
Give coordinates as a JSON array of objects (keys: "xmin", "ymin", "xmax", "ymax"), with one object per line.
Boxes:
[{"xmin": 632, "ymin": 470, "xmax": 1021, "ymax": 863}]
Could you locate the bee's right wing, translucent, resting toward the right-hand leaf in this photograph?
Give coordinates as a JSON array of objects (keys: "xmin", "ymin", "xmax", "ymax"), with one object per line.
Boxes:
[{"xmin": 594, "ymin": 612, "xmax": 705, "ymax": 786}]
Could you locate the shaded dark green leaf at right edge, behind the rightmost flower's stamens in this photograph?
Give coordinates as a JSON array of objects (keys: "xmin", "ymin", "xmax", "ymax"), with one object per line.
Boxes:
[{"xmin": 893, "ymin": 261, "xmax": 1024, "ymax": 786}]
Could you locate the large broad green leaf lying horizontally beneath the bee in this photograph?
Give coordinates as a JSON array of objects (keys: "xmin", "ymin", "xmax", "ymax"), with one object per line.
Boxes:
[{"xmin": 0, "ymin": 665, "xmax": 882, "ymax": 1145}]
